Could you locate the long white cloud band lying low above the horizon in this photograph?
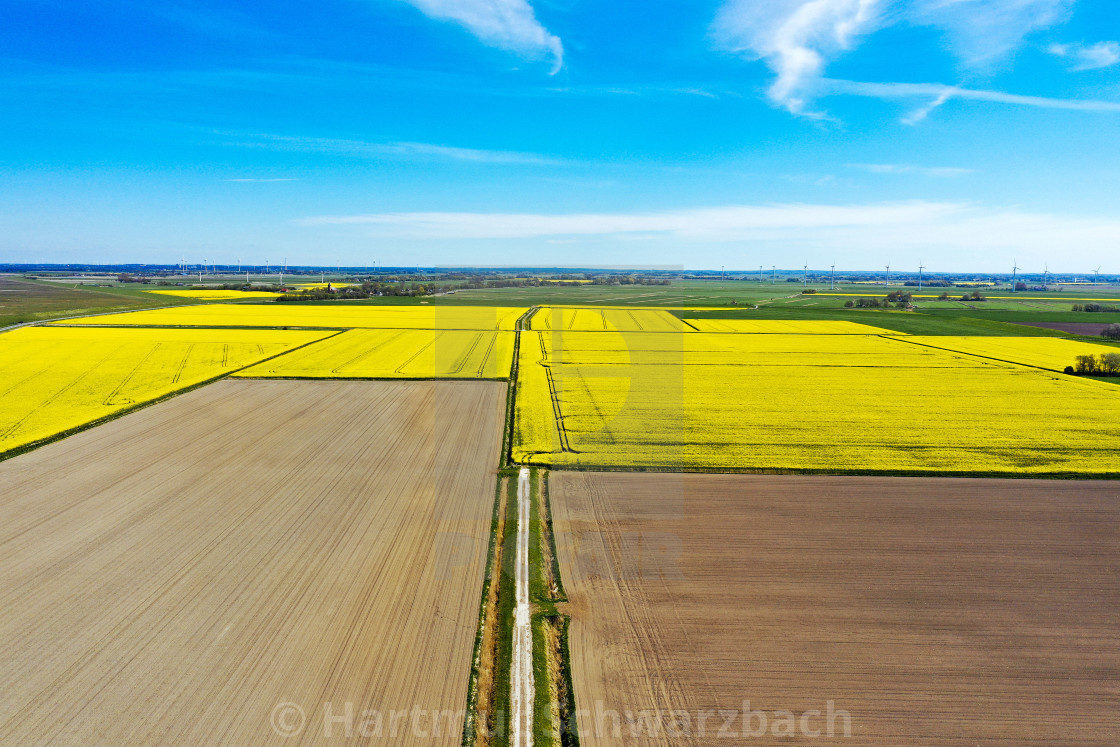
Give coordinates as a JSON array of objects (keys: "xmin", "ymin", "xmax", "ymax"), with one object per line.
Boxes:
[{"xmin": 297, "ymin": 202, "xmax": 1120, "ymax": 267}]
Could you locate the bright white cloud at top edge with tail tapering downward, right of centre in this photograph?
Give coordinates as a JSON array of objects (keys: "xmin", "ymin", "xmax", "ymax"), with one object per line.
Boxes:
[{"xmin": 712, "ymin": 0, "xmax": 879, "ymax": 114}]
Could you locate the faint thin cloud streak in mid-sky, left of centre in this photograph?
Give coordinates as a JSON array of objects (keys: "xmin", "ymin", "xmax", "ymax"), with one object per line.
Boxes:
[{"xmin": 217, "ymin": 132, "xmax": 561, "ymax": 166}]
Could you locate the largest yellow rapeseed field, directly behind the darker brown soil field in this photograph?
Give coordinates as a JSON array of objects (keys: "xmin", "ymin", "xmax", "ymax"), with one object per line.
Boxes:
[{"xmin": 513, "ymin": 333, "xmax": 1120, "ymax": 474}]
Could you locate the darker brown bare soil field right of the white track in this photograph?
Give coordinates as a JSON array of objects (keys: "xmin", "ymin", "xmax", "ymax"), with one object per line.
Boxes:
[{"xmin": 550, "ymin": 473, "xmax": 1120, "ymax": 747}]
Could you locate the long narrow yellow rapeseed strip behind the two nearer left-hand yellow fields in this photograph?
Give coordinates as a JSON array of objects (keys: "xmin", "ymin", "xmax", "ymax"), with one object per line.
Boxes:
[{"xmin": 50, "ymin": 302, "xmax": 525, "ymax": 330}]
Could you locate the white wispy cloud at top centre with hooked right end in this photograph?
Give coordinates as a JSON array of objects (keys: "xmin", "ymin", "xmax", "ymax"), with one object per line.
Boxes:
[{"xmin": 403, "ymin": 0, "xmax": 563, "ymax": 73}]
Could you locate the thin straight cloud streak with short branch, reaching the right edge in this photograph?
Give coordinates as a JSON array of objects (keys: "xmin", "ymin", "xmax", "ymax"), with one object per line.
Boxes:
[{"xmin": 822, "ymin": 80, "xmax": 1120, "ymax": 124}]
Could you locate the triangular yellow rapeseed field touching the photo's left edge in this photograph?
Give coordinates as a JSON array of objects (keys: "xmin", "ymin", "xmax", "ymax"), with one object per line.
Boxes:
[{"xmin": 0, "ymin": 327, "xmax": 330, "ymax": 452}]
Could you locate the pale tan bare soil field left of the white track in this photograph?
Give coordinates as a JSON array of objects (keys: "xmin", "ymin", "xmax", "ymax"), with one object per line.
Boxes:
[{"xmin": 0, "ymin": 381, "xmax": 505, "ymax": 746}]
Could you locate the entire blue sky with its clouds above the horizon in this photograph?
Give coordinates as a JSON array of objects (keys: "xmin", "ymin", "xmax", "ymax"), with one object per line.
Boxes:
[{"xmin": 0, "ymin": 0, "xmax": 1120, "ymax": 272}]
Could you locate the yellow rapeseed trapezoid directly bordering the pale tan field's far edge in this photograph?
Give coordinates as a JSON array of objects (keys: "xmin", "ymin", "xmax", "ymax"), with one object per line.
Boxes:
[{"xmin": 234, "ymin": 329, "xmax": 514, "ymax": 379}]
